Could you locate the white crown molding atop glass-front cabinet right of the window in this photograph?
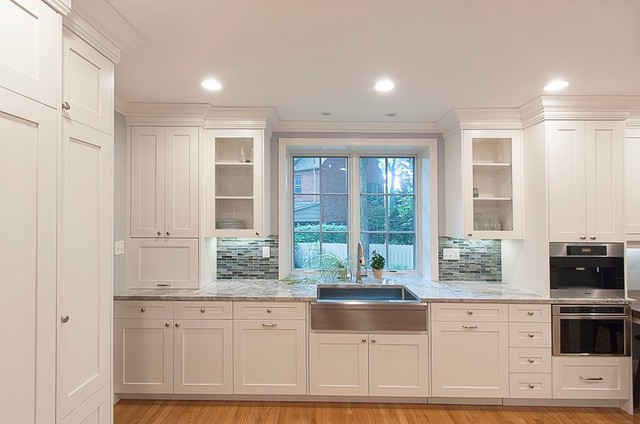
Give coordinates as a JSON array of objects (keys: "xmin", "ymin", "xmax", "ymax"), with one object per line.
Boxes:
[{"xmin": 437, "ymin": 108, "xmax": 522, "ymax": 138}]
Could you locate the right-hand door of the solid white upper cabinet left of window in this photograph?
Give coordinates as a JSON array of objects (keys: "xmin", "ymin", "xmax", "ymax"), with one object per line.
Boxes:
[{"xmin": 163, "ymin": 128, "xmax": 199, "ymax": 237}]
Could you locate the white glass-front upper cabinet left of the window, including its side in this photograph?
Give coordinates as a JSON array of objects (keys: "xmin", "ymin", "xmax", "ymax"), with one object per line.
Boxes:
[{"xmin": 206, "ymin": 130, "xmax": 271, "ymax": 237}]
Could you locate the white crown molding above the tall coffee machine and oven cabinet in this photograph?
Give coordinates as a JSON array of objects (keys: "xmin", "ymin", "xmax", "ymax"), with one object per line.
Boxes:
[{"xmin": 519, "ymin": 96, "xmax": 640, "ymax": 128}]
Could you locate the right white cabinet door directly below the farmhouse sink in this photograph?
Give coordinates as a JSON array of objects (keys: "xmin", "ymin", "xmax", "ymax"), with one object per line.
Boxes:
[{"xmin": 369, "ymin": 334, "xmax": 429, "ymax": 397}]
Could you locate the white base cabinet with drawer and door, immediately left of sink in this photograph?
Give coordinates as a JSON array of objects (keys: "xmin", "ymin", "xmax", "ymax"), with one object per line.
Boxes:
[{"xmin": 233, "ymin": 302, "xmax": 307, "ymax": 395}]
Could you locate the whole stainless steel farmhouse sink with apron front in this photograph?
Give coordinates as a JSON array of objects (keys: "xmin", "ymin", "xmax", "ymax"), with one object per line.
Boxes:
[{"xmin": 311, "ymin": 286, "xmax": 428, "ymax": 332}]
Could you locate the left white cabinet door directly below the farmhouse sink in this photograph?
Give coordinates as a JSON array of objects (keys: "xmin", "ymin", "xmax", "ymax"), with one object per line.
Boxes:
[{"xmin": 309, "ymin": 333, "xmax": 369, "ymax": 396}]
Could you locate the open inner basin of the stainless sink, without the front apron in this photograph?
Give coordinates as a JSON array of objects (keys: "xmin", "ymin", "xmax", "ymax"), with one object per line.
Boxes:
[{"xmin": 316, "ymin": 286, "xmax": 420, "ymax": 303}]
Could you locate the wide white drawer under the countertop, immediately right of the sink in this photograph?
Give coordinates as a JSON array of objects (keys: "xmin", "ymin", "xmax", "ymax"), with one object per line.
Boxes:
[{"xmin": 431, "ymin": 303, "xmax": 509, "ymax": 322}]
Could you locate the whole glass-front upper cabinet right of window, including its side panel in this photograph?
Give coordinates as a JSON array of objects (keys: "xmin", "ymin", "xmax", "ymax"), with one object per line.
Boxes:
[{"xmin": 445, "ymin": 126, "xmax": 522, "ymax": 239}]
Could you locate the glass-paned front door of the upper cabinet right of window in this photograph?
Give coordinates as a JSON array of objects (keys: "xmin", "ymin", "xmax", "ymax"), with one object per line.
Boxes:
[{"xmin": 462, "ymin": 130, "xmax": 522, "ymax": 239}]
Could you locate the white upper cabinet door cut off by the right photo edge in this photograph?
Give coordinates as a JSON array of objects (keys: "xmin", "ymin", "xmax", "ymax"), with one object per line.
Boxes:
[{"xmin": 624, "ymin": 128, "xmax": 640, "ymax": 241}]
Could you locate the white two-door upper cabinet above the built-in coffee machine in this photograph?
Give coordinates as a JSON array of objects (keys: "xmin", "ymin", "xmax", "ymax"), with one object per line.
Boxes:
[{"xmin": 546, "ymin": 121, "xmax": 624, "ymax": 242}]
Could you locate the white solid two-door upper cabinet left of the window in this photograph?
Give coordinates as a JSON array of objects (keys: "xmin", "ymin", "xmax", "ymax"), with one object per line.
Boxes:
[{"xmin": 130, "ymin": 127, "xmax": 199, "ymax": 238}]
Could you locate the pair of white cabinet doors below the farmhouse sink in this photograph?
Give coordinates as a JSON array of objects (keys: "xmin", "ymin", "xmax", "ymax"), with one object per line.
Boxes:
[{"xmin": 309, "ymin": 333, "xmax": 429, "ymax": 397}]
